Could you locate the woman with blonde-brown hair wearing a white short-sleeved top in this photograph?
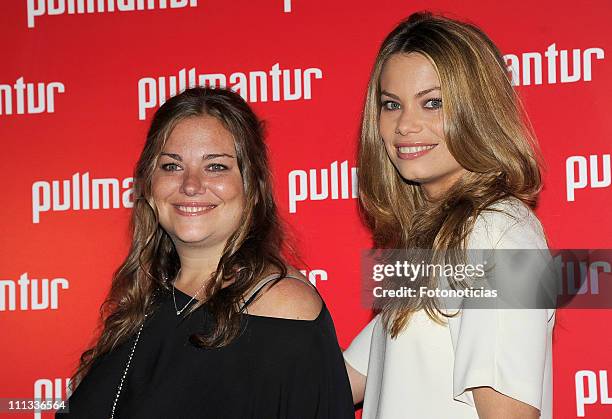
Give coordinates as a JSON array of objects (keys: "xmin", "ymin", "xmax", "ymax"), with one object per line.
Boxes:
[{"xmin": 344, "ymin": 13, "xmax": 554, "ymax": 419}]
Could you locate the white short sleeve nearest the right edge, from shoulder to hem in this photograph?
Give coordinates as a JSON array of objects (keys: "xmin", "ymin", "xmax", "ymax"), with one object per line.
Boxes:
[{"xmin": 449, "ymin": 202, "xmax": 554, "ymax": 410}]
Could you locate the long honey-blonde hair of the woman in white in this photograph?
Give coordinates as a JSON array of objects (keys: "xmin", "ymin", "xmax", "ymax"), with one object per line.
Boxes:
[{"xmin": 358, "ymin": 12, "xmax": 542, "ymax": 337}]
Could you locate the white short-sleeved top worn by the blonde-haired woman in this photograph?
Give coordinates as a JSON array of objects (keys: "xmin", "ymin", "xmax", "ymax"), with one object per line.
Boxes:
[{"xmin": 344, "ymin": 199, "xmax": 554, "ymax": 419}]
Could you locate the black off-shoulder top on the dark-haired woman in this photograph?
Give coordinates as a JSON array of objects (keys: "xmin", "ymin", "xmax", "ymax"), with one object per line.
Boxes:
[{"xmin": 56, "ymin": 289, "xmax": 354, "ymax": 419}]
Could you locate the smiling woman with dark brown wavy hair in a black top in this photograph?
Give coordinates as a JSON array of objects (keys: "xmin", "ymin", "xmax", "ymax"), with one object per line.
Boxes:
[{"xmin": 58, "ymin": 88, "xmax": 353, "ymax": 419}]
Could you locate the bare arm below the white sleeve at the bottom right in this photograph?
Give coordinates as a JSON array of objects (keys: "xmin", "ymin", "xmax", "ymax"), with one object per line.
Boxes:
[{"xmin": 471, "ymin": 387, "xmax": 540, "ymax": 419}]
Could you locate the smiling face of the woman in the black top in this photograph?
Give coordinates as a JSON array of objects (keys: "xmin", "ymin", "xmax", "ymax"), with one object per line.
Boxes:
[{"xmin": 151, "ymin": 116, "xmax": 244, "ymax": 248}]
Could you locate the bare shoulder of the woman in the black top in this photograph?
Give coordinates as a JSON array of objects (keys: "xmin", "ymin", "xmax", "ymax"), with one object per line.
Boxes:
[{"xmin": 247, "ymin": 270, "xmax": 323, "ymax": 320}]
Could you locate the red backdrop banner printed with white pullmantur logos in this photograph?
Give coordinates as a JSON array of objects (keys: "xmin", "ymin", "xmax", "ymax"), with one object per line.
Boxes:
[{"xmin": 0, "ymin": 0, "xmax": 612, "ymax": 418}]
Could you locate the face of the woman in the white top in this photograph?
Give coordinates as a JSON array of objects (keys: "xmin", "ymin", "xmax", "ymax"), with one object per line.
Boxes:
[{"xmin": 379, "ymin": 53, "xmax": 465, "ymax": 197}]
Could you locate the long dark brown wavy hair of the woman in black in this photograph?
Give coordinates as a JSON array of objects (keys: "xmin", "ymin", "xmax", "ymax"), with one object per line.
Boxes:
[{"xmin": 72, "ymin": 87, "xmax": 287, "ymax": 388}]
